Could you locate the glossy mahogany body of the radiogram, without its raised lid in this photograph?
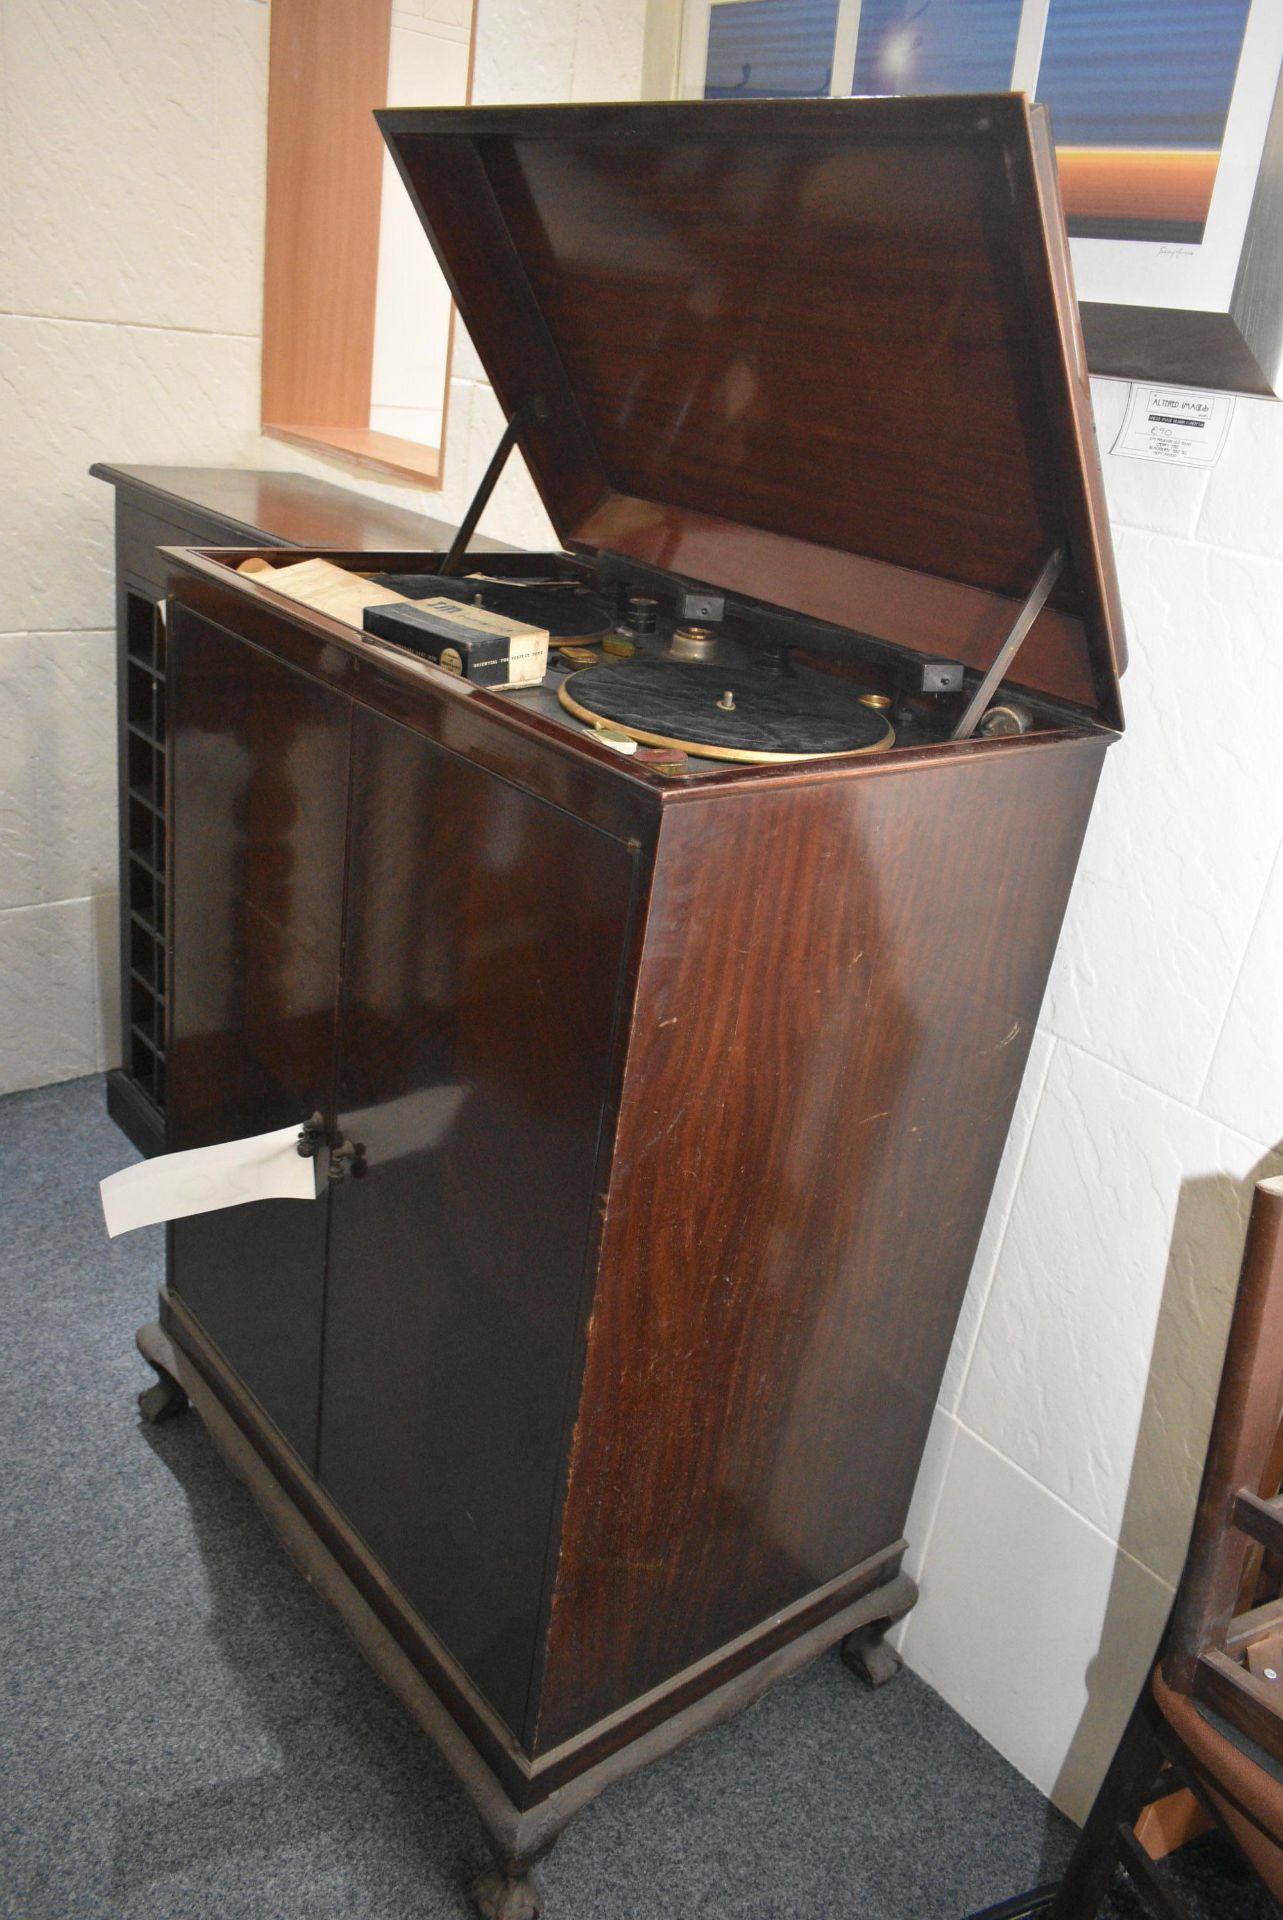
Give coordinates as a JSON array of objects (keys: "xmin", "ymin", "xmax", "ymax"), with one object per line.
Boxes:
[{"xmin": 150, "ymin": 545, "xmax": 1106, "ymax": 1889}]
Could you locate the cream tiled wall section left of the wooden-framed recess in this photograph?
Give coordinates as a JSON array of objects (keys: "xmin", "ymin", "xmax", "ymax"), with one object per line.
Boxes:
[{"xmin": 0, "ymin": 0, "xmax": 267, "ymax": 1091}]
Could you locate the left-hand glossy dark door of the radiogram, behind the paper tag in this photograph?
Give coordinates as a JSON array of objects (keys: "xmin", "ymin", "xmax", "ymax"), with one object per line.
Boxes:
[{"xmin": 167, "ymin": 609, "xmax": 351, "ymax": 1467}]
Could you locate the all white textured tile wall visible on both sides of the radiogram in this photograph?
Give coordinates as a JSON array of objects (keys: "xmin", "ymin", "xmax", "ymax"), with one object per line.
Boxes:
[{"xmin": 0, "ymin": 0, "xmax": 1283, "ymax": 1812}]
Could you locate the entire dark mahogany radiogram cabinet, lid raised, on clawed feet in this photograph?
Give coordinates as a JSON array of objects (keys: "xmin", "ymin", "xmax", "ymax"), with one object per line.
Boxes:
[{"xmin": 140, "ymin": 98, "xmax": 1122, "ymax": 1920}]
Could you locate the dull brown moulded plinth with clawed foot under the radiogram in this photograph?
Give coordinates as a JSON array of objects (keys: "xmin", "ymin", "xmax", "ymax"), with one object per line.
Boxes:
[{"xmin": 138, "ymin": 1288, "xmax": 918, "ymax": 1920}]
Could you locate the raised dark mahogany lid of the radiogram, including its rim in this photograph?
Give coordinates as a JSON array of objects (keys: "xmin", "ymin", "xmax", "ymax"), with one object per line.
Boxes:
[{"xmin": 378, "ymin": 94, "xmax": 1122, "ymax": 726}]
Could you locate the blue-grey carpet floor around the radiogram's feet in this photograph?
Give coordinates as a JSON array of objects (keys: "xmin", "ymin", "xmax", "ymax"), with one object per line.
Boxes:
[{"xmin": 0, "ymin": 1079, "xmax": 1273, "ymax": 1920}]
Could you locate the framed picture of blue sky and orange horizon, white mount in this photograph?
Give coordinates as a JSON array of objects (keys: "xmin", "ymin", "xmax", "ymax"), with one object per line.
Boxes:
[{"xmin": 682, "ymin": 0, "xmax": 1283, "ymax": 394}]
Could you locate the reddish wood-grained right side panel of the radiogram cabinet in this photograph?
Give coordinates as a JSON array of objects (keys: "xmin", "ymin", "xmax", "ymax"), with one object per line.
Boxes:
[{"xmin": 538, "ymin": 739, "xmax": 1104, "ymax": 1751}]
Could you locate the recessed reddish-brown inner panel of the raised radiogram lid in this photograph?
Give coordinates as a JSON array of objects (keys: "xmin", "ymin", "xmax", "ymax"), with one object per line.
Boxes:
[{"xmin": 490, "ymin": 138, "xmax": 1064, "ymax": 593}]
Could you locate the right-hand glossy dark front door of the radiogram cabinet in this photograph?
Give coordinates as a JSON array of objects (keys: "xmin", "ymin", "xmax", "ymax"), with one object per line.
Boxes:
[{"xmin": 321, "ymin": 708, "xmax": 638, "ymax": 1732}]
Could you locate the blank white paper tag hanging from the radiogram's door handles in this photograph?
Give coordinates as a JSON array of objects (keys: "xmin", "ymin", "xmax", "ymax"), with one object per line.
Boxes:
[{"xmin": 98, "ymin": 1127, "xmax": 317, "ymax": 1238}]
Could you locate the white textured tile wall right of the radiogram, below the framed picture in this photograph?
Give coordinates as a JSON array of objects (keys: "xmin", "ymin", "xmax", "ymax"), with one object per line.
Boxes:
[{"xmin": 903, "ymin": 380, "xmax": 1283, "ymax": 1818}]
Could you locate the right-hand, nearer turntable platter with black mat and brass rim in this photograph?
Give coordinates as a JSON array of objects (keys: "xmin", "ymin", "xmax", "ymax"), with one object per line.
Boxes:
[{"xmin": 563, "ymin": 660, "xmax": 891, "ymax": 755}]
